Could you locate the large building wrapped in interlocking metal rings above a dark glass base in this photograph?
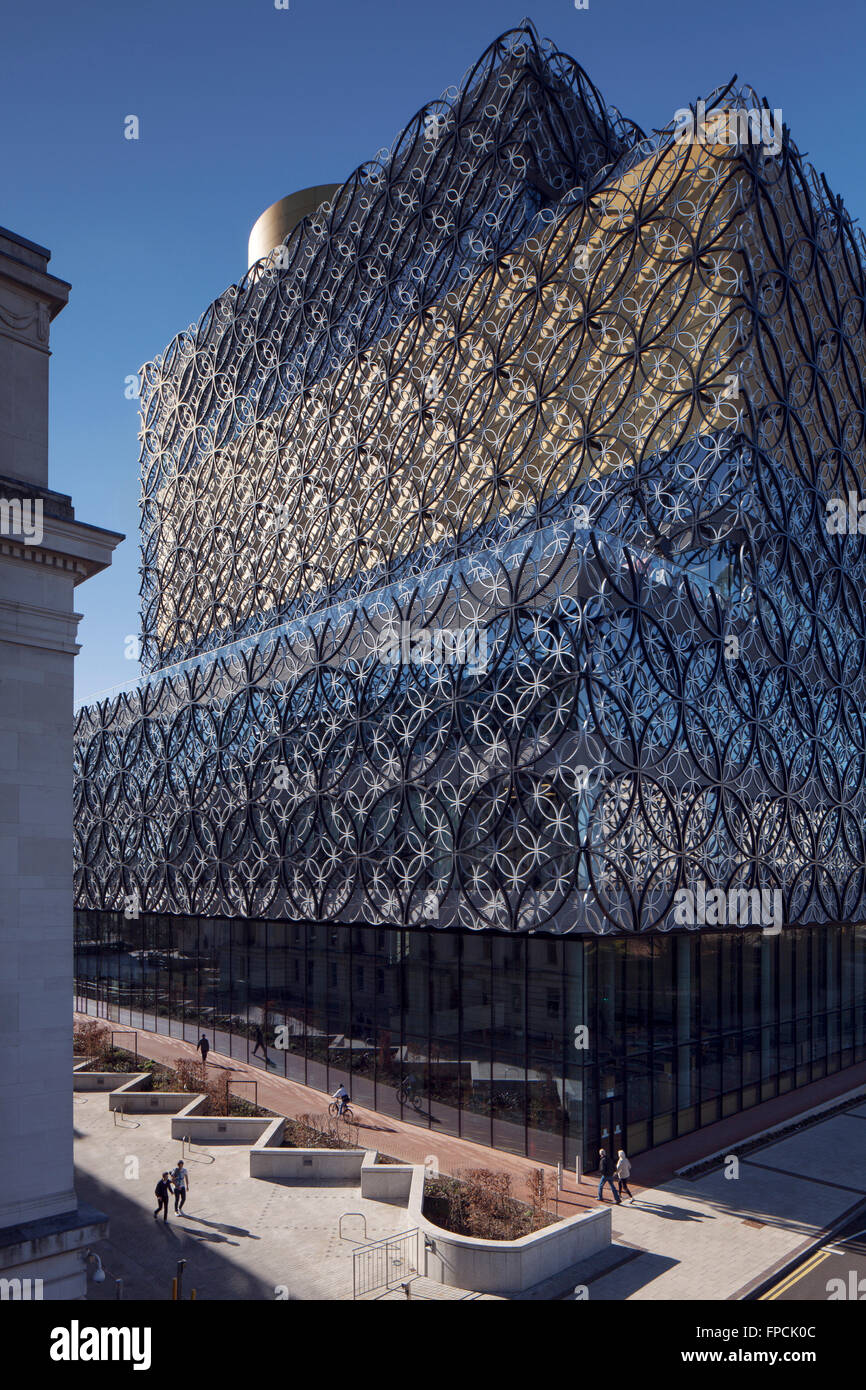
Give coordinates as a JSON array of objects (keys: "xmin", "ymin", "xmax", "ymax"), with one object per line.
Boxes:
[{"xmin": 76, "ymin": 26, "xmax": 866, "ymax": 1156}]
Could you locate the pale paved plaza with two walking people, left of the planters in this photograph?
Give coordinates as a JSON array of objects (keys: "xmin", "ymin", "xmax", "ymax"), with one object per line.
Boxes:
[{"xmin": 75, "ymin": 1094, "xmax": 406, "ymax": 1300}]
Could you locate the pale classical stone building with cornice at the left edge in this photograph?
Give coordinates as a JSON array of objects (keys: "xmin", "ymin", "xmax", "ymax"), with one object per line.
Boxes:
[{"xmin": 0, "ymin": 228, "xmax": 122, "ymax": 1298}]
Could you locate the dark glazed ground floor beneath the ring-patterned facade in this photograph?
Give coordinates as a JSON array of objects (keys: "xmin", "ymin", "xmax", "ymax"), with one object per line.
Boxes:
[{"xmin": 75, "ymin": 910, "xmax": 866, "ymax": 1168}]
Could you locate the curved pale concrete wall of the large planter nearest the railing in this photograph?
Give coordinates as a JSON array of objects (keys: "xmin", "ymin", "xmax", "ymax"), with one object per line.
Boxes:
[{"xmin": 409, "ymin": 1165, "xmax": 612, "ymax": 1295}]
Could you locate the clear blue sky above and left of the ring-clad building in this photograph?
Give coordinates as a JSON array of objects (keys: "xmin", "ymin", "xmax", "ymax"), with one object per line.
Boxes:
[{"xmin": 0, "ymin": 0, "xmax": 866, "ymax": 699}]
